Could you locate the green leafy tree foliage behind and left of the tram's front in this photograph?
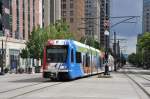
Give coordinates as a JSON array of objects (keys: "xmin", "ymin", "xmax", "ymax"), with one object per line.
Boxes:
[{"xmin": 26, "ymin": 20, "xmax": 74, "ymax": 59}]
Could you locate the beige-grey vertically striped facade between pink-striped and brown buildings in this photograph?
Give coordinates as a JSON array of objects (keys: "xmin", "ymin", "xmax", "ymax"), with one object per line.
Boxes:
[{"xmin": 42, "ymin": 0, "xmax": 61, "ymax": 27}]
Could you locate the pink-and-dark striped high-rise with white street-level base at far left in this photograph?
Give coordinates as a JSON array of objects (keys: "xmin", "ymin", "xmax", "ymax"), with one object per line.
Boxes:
[{"xmin": 0, "ymin": 0, "xmax": 42, "ymax": 69}]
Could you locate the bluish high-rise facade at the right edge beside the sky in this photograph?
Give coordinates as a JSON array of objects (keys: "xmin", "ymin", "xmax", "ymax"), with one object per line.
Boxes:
[{"xmin": 143, "ymin": 0, "xmax": 150, "ymax": 33}]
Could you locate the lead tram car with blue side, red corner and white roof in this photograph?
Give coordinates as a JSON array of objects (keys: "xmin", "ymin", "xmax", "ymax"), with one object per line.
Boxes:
[{"xmin": 43, "ymin": 40, "xmax": 104, "ymax": 80}]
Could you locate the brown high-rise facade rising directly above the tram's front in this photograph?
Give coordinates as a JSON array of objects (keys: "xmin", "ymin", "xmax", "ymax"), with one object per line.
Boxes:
[{"xmin": 61, "ymin": 0, "xmax": 85, "ymax": 40}]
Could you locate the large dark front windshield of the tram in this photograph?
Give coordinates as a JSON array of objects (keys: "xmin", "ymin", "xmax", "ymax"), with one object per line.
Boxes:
[{"xmin": 46, "ymin": 45, "xmax": 68, "ymax": 63}]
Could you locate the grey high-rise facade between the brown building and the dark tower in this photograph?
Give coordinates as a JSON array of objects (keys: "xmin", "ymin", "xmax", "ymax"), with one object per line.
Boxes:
[{"xmin": 84, "ymin": 0, "xmax": 100, "ymax": 42}]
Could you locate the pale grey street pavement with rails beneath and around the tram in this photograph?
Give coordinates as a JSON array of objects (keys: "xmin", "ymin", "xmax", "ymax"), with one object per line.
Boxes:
[{"xmin": 0, "ymin": 65, "xmax": 150, "ymax": 99}]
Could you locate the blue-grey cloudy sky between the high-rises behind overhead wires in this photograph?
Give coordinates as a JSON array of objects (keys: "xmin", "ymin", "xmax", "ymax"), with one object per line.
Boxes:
[{"xmin": 110, "ymin": 0, "xmax": 143, "ymax": 54}]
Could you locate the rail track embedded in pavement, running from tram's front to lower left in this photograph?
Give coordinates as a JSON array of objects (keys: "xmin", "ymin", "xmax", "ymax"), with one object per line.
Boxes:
[{"xmin": 0, "ymin": 81, "xmax": 65, "ymax": 99}]
